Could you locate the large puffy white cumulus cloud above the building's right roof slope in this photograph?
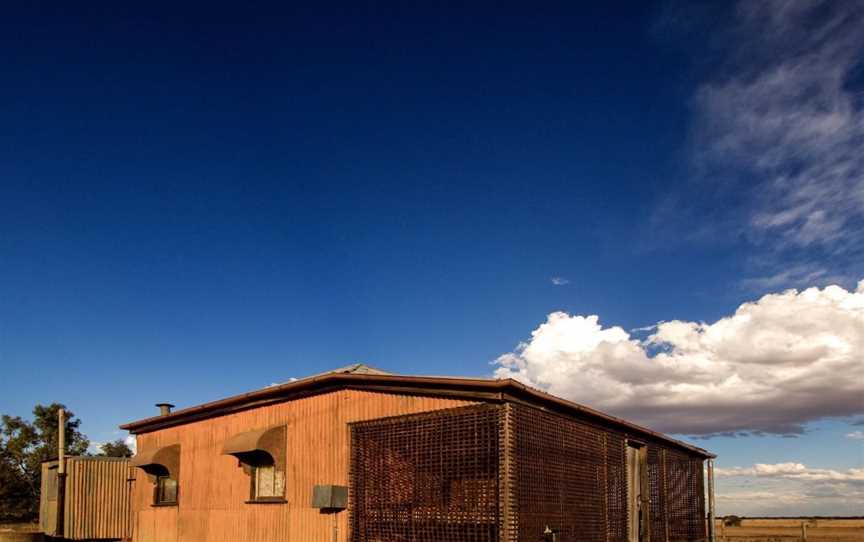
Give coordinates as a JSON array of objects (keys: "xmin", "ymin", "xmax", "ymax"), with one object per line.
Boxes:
[{"xmin": 494, "ymin": 280, "xmax": 864, "ymax": 435}]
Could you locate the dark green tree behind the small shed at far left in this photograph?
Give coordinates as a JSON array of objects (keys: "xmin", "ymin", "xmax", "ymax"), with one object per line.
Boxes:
[{"xmin": 0, "ymin": 403, "xmax": 90, "ymax": 521}]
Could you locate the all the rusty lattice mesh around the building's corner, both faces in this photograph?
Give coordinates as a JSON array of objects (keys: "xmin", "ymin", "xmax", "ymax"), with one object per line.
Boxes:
[{"xmin": 350, "ymin": 402, "xmax": 706, "ymax": 542}]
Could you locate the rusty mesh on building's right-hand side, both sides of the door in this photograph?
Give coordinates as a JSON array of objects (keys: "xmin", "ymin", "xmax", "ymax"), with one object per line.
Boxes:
[{"xmin": 511, "ymin": 404, "xmax": 705, "ymax": 542}]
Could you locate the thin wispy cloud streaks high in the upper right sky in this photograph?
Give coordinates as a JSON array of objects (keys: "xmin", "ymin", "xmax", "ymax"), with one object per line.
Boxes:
[{"xmin": 695, "ymin": 0, "xmax": 864, "ymax": 253}]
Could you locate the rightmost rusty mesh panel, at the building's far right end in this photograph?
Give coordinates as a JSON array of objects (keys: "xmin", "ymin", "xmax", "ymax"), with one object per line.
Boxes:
[{"xmin": 666, "ymin": 450, "xmax": 706, "ymax": 540}]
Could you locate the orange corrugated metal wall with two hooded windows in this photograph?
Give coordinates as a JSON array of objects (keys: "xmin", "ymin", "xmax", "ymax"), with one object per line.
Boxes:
[{"xmin": 133, "ymin": 389, "xmax": 472, "ymax": 542}]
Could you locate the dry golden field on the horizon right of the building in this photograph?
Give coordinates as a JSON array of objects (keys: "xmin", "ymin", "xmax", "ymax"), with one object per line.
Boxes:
[{"xmin": 716, "ymin": 518, "xmax": 864, "ymax": 542}]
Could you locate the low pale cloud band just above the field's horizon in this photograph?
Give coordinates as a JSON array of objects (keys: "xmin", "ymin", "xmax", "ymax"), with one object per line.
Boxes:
[{"xmin": 714, "ymin": 463, "xmax": 864, "ymax": 515}]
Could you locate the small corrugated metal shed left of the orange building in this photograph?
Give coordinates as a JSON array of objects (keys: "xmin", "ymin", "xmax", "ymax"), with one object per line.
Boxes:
[{"xmin": 39, "ymin": 457, "xmax": 135, "ymax": 540}]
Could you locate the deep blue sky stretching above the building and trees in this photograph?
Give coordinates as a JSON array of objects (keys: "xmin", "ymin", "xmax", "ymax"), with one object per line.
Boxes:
[{"xmin": 0, "ymin": 2, "xmax": 864, "ymax": 513}]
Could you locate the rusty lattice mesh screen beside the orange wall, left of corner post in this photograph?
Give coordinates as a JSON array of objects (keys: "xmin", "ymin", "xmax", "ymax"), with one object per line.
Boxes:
[{"xmin": 350, "ymin": 404, "xmax": 503, "ymax": 542}]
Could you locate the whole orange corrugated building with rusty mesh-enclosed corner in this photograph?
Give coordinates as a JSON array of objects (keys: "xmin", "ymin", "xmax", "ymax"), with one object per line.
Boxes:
[{"xmin": 122, "ymin": 365, "xmax": 713, "ymax": 542}]
